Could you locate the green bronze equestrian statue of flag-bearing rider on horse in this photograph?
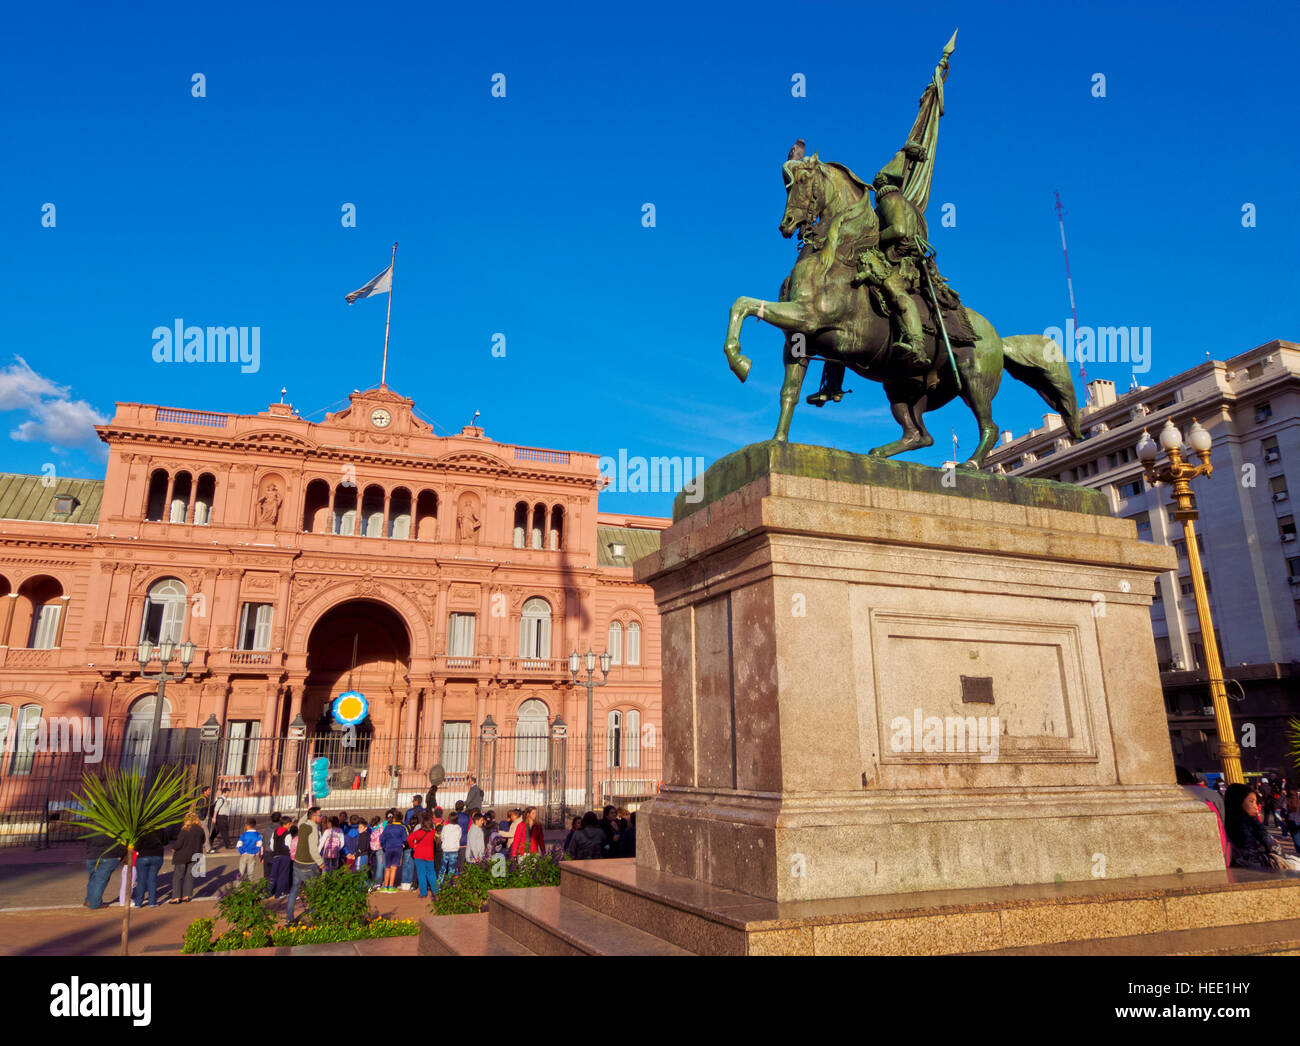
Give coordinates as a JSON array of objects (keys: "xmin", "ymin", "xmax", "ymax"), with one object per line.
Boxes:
[{"xmin": 723, "ymin": 32, "xmax": 1083, "ymax": 469}]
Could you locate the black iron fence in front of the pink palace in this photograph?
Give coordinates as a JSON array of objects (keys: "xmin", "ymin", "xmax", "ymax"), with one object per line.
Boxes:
[{"xmin": 0, "ymin": 728, "xmax": 662, "ymax": 847}]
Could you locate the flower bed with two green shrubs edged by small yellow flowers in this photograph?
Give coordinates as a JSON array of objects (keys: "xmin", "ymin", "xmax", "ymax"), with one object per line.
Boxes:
[{"xmin": 181, "ymin": 871, "xmax": 420, "ymax": 955}]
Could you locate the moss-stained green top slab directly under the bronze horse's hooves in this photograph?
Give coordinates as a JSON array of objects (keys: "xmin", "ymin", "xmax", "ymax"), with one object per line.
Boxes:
[{"xmin": 672, "ymin": 440, "xmax": 1110, "ymax": 522}]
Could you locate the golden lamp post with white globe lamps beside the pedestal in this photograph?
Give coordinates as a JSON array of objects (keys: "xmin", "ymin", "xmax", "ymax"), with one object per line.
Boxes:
[{"xmin": 1138, "ymin": 418, "xmax": 1244, "ymax": 785}]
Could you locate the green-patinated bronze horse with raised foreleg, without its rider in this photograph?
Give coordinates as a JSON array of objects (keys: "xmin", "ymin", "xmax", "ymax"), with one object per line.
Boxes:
[{"xmin": 723, "ymin": 143, "xmax": 1083, "ymax": 469}]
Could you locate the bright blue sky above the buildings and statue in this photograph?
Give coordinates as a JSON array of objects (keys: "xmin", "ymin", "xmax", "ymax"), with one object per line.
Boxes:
[{"xmin": 0, "ymin": 3, "xmax": 1300, "ymax": 513}]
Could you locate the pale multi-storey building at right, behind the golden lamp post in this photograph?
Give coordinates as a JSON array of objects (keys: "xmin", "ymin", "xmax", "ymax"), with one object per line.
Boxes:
[{"xmin": 987, "ymin": 340, "xmax": 1300, "ymax": 776}]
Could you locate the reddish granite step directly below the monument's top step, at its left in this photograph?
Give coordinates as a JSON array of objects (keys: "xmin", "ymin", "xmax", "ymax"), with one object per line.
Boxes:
[{"xmin": 488, "ymin": 886, "xmax": 690, "ymax": 955}]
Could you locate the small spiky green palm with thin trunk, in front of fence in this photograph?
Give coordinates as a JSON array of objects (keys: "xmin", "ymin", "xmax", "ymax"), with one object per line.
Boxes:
[{"xmin": 68, "ymin": 767, "xmax": 199, "ymax": 955}]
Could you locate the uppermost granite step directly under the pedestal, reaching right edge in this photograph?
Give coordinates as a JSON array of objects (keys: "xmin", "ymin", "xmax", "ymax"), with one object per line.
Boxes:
[{"xmin": 559, "ymin": 860, "xmax": 1300, "ymax": 955}]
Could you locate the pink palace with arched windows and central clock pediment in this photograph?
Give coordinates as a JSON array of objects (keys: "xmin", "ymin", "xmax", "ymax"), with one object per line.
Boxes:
[{"xmin": 0, "ymin": 386, "xmax": 668, "ymax": 826}]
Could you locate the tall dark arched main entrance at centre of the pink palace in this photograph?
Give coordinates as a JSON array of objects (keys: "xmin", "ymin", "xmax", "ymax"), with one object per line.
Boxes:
[{"xmin": 302, "ymin": 599, "xmax": 411, "ymax": 778}]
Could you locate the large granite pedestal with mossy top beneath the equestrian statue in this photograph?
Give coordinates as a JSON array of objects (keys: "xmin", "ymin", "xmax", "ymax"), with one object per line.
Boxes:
[{"xmin": 634, "ymin": 443, "xmax": 1223, "ymax": 902}]
